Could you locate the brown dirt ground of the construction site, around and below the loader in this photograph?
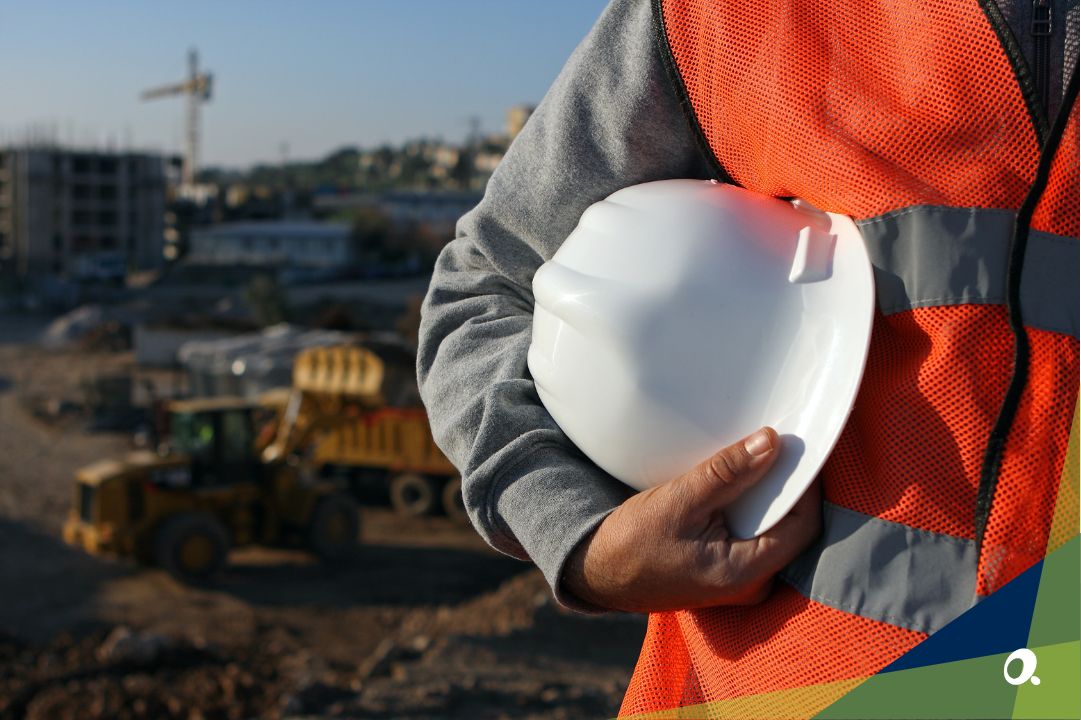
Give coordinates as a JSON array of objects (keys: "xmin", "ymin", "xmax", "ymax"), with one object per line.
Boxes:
[{"xmin": 0, "ymin": 317, "xmax": 644, "ymax": 719}]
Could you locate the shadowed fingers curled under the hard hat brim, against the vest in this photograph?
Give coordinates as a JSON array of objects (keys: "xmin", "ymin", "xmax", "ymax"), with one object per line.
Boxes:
[{"xmin": 729, "ymin": 481, "xmax": 822, "ymax": 581}]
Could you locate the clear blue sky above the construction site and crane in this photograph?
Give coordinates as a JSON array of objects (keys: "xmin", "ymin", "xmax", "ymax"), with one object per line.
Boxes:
[{"xmin": 0, "ymin": 0, "xmax": 605, "ymax": 166}]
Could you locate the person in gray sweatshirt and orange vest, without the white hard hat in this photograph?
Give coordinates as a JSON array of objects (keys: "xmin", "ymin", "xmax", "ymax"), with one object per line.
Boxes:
[{"xmin": 418, "ymin": 0, "xmax": 1079, "ymax": 717}]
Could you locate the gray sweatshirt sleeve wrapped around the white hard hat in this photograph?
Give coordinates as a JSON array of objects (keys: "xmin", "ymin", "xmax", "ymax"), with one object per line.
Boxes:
[{"xmin": 417, "ymin": 0, "xmax": 710, "ymax": 608}]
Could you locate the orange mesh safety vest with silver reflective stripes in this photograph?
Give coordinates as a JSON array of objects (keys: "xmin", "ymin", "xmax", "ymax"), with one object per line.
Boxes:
[{"xmin": 620, "ymin": 0, "xmax": 1079, "ymax": 717}]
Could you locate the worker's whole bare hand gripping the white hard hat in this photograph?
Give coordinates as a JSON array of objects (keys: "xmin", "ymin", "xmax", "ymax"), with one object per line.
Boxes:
[{"xmin": 563, "ymin": 428, "xmax": 822, "ymax": 612}]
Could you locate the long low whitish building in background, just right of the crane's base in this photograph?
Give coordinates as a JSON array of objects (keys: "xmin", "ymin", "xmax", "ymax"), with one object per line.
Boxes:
[{"xmin": 188, "ymin": 221, "xmax": 352, "ymax": 269}]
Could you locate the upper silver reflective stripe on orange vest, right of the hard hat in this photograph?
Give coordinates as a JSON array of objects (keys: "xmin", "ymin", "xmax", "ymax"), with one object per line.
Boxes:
[{"xmin": 857, "ymin": 205, "xmax": 1079, "ymax": 337}]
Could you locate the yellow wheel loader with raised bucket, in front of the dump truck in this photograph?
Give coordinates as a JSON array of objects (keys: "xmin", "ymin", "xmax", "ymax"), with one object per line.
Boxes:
[{"xmin": 64, "ymin": 347, "xmax": 383, "ymax": 582}]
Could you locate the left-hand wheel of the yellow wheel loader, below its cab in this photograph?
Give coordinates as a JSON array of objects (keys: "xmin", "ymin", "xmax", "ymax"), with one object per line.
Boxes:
[{"xmin": 154, "ymin": 511, "xmax": 229, "ymax": 585}]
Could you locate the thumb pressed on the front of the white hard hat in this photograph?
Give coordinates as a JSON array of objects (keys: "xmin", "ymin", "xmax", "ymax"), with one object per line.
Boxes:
[{"xmin": 672, "ymin": 427, "xmax": 780, "ymax": 509}]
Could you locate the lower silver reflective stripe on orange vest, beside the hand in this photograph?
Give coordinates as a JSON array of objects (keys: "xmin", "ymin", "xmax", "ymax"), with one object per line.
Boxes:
[{"xmin": 780, "ymin": 503, "xmax": 977, "ymax": 632}]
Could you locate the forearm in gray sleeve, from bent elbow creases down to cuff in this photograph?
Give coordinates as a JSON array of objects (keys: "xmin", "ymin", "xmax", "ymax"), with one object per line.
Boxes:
[{"xmin": 418, "ymin": 206, "xmax": 629, "ymax": 604}]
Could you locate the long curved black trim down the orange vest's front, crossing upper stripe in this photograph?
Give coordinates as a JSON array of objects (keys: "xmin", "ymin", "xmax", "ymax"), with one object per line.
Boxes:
[{"xmin": 976, "ymin": 64, "xmax": 1078, "ymax": 547}]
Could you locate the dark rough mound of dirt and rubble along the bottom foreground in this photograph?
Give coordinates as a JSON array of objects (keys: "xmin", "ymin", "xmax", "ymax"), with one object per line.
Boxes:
[{"xmin": 0, "ymin": 573, "xmax": 641, "ymax": 720}]
